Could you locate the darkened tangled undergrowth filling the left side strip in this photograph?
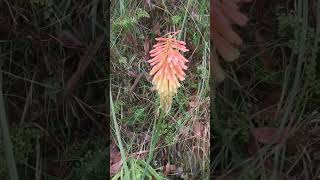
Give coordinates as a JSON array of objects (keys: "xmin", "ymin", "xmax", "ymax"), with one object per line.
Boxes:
[{"xmin": 0, "ymin": 0, "xmax": 107, "ymax": 180}]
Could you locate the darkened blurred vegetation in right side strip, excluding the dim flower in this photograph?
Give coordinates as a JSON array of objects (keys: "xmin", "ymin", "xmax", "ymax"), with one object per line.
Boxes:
[{"xmin": 211, "ymin": 0, "xmax": 320, "ymax": 180}]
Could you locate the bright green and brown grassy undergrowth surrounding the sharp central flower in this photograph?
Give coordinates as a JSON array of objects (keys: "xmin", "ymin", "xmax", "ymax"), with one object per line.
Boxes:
[{"xmin": 110, "ymin": 0, "xmax": 210, "ymax": 179}]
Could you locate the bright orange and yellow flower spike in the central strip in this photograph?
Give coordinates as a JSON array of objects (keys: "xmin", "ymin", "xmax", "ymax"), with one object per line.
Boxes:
[{"xmin": 148, "ymin": 31, "xmax": 189, "ymax": 112}]
